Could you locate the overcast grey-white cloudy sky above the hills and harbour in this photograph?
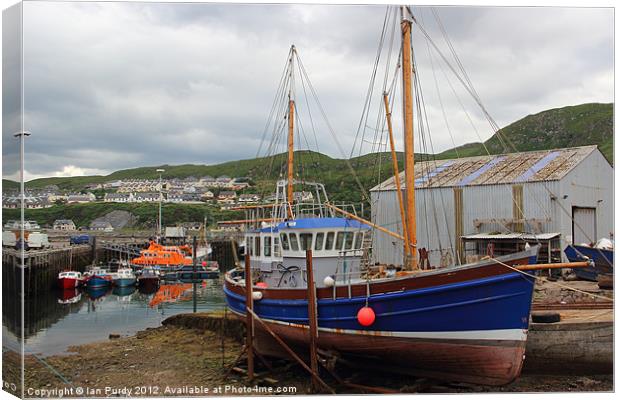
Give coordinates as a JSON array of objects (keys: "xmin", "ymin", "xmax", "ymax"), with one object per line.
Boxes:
[{"xmin": 3, "ymin": 2, "xmax": 614, "ymax": 179}]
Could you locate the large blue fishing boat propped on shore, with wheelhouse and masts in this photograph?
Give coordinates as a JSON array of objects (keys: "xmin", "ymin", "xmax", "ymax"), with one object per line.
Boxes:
[{"xmin": 224, "ymin": 14, "xmax": 556, "ymax": 385}]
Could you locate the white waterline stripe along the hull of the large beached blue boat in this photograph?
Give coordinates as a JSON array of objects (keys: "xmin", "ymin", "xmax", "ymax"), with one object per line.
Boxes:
[{"xmin": 228, "ymin": 311, "xmax": 527, "ymax": 342}]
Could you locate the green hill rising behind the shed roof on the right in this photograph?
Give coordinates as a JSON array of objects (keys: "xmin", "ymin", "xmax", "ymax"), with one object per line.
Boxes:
[{"xmin": 437, "ymin": 103, "xmax": 614, "ymax": 163}]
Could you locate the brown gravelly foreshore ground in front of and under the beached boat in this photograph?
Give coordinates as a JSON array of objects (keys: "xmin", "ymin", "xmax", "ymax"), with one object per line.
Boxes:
[{"xmin": 2, "ymin": 325, "xmax": 613, "ymax": 397}]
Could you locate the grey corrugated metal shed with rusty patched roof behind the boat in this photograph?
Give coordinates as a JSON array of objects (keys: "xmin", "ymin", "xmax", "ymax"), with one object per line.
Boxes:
[{"xmin": 370, "ymin": 146, "xmax": 614, "ymax": 265}]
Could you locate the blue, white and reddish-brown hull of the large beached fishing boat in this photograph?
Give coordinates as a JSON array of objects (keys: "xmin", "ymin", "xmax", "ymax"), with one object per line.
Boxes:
[{"xmin": 224, "ymin": 252, "xmax": 534, "ymax": 385}]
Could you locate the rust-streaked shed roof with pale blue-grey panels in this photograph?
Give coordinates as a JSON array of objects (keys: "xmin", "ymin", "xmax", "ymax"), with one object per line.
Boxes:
[{"xmin": 370, "ymin": 146, "xmax": 597, "ymax": 191}]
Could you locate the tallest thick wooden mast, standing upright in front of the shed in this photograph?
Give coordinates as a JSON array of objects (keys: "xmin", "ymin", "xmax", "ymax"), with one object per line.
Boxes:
[{"xmin": 401, "ymin": 6, "xmax": 418, "ymax": 269}]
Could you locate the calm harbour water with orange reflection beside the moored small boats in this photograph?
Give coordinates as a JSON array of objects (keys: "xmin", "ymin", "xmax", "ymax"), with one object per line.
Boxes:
[{"xmin": 2, "ymin": 280, "xmax": 225, "ymax": 355}]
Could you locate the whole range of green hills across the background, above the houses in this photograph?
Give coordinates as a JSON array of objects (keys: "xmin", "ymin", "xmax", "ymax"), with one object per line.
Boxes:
[{"xmin": 3, "ymin": 103, "xmax": 613, "ymax": 201}]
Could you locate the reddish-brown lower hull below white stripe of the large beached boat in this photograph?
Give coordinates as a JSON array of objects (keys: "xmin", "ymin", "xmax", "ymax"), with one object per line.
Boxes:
[{"xmin": 249, "ymin": 321, "xmax": 526, "ymax": 386}]
